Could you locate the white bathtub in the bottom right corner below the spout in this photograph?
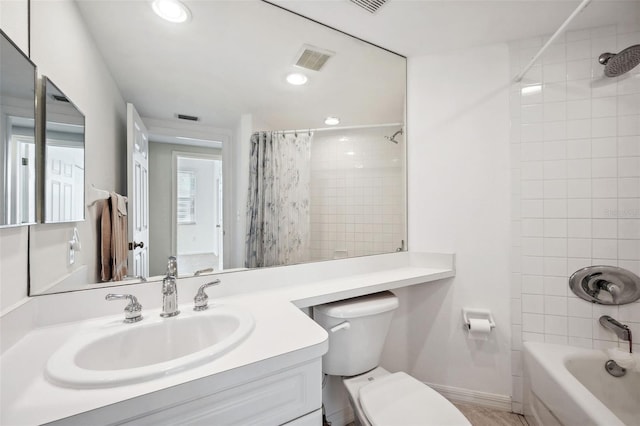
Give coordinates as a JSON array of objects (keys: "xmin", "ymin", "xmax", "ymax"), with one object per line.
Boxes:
[{"xmin": 524, "ymin": 342, "xmax": 640, "ymax": 426}]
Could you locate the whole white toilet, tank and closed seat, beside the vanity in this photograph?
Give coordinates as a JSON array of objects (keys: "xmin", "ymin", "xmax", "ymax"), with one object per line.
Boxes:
[{"xmin": 313, "ymin": 291, "xmax": 471, "ymax": 426}]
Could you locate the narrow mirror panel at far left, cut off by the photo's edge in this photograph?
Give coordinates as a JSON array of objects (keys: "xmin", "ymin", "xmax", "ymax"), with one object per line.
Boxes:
[{"xmin": 0, "ymin": 31, "xmax": 36, "ymax": 226}]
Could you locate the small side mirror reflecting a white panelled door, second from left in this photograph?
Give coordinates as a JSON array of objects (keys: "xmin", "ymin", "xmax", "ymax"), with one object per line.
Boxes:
[{"xmin": 41, "ymin": 77, "xmax": 84, "ymax": 223}]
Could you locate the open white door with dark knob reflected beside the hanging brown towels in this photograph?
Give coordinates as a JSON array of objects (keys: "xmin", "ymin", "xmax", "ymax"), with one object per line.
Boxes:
[{"xmin": 127, "ymin": 104, "xmax": 149, "ymax": 278}]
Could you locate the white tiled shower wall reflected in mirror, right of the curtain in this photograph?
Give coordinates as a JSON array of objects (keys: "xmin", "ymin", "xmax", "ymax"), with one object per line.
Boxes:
[{"xmin": 311, "ymin": 126, "xmax": 406, "ymax": 260}]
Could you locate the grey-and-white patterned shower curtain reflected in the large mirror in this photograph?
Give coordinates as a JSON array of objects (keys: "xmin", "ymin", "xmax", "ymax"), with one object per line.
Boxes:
[{"xmin": 245, "ymin": 132, "xmax": 313, "ymax": 268}]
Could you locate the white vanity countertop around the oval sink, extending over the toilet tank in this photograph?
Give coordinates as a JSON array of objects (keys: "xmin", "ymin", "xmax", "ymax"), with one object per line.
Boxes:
[{"xmin": 0, "ymin": 251, "xmax": 455, "ymax": 426}]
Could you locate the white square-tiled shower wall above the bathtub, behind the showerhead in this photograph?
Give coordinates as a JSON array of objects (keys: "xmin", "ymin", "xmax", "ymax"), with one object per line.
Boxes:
[{"xmin": 510, "ymin": 26, "xmax": 640, "ymax": 410}]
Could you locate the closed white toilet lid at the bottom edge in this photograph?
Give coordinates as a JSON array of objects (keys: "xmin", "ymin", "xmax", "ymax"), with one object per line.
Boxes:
[{"xmin": 359, "ymin": 372, "xmax": 471, "ymax": 426}]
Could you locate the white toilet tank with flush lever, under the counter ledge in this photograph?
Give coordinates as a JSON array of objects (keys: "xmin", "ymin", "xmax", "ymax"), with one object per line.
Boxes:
[{"xmin": 313, "ymin": 291, "xmax": 398, "ymax": 376}]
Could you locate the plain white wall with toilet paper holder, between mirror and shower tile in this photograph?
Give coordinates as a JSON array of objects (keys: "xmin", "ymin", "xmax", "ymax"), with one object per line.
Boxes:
[{"xmin": 390, "ymin": 45, "xmax": 511, "ymax": 396}]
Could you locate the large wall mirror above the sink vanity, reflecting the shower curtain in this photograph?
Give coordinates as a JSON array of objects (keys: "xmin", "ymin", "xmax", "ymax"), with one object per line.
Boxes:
[{"xmin": 31, "ymin": 0, "xmax": 407, "ymax": 294}]
